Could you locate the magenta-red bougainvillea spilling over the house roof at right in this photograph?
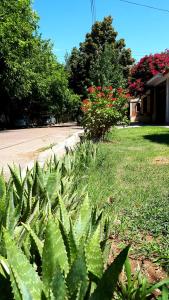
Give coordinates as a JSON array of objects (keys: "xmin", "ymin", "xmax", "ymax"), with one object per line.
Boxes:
[{"xmin": 129, "ymin": 50, "xmax": 169, "ymax": 96}]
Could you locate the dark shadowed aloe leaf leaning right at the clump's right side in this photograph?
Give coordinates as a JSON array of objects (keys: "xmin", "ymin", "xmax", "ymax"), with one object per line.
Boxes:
[{"xmin": 90, "ymin": 246, "xmax": 129, "ymax": 300}]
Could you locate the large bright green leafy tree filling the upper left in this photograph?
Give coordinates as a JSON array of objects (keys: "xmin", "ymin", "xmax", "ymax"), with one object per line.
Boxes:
[{"xmin": 0, "ymin": 0, "xmax": 77, "ymax": 122}]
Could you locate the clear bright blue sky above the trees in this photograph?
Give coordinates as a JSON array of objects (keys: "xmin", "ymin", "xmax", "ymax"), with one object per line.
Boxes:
[{"xmin": 33, "ymin": 0, "xmax": 169, "ymax": 62}]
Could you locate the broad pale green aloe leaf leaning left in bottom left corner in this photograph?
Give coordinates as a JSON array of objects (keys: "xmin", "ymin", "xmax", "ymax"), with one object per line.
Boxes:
[{"xmin": 4, "ymin": 230, "xmax": 42, "ymax": 300}]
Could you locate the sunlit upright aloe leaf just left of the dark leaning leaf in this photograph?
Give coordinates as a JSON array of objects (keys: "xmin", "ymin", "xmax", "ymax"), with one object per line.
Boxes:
[{"xmin": 85, "ymin": 226, "xmax": 103, "ymax": 278}]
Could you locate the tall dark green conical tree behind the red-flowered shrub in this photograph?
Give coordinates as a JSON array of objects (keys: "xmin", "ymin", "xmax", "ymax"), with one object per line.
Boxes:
[{"xmin": 66, "ymin": 16, "xmax": 133, "ymax": 96}]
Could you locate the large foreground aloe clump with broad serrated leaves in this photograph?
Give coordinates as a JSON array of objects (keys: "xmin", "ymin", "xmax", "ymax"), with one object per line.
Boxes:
[{"xmin": 1, "ymin": 193, "xmax": 128, "ymax": 300}]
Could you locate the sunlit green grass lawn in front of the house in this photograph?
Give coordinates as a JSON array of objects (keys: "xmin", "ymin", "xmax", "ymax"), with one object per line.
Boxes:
[{"xmin": 79, "ymin": 126, "xmax": 169, "ymax": 270}]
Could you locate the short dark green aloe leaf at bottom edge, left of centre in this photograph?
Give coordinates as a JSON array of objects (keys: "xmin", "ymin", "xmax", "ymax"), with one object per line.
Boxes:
[{"xmin": 51, "ymin": 265, "xmax": 67, "ymax": 300}]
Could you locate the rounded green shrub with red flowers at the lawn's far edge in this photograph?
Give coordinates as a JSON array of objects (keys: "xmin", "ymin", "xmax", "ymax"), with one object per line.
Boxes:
[{"xmin": 82, "ymin": 86, "xmax": 130, "ymax": 140}]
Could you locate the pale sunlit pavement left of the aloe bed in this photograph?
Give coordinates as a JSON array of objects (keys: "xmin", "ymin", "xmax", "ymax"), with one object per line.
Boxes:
[{"xmin": 0, "ymin": 123, "xmax": 83, "ymax": 178}]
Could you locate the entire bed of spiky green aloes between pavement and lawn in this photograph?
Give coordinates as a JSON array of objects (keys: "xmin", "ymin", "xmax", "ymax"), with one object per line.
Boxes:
[{"xmin": 0, "ymin": 142, "xmax": 169, "ymax": 300}]
